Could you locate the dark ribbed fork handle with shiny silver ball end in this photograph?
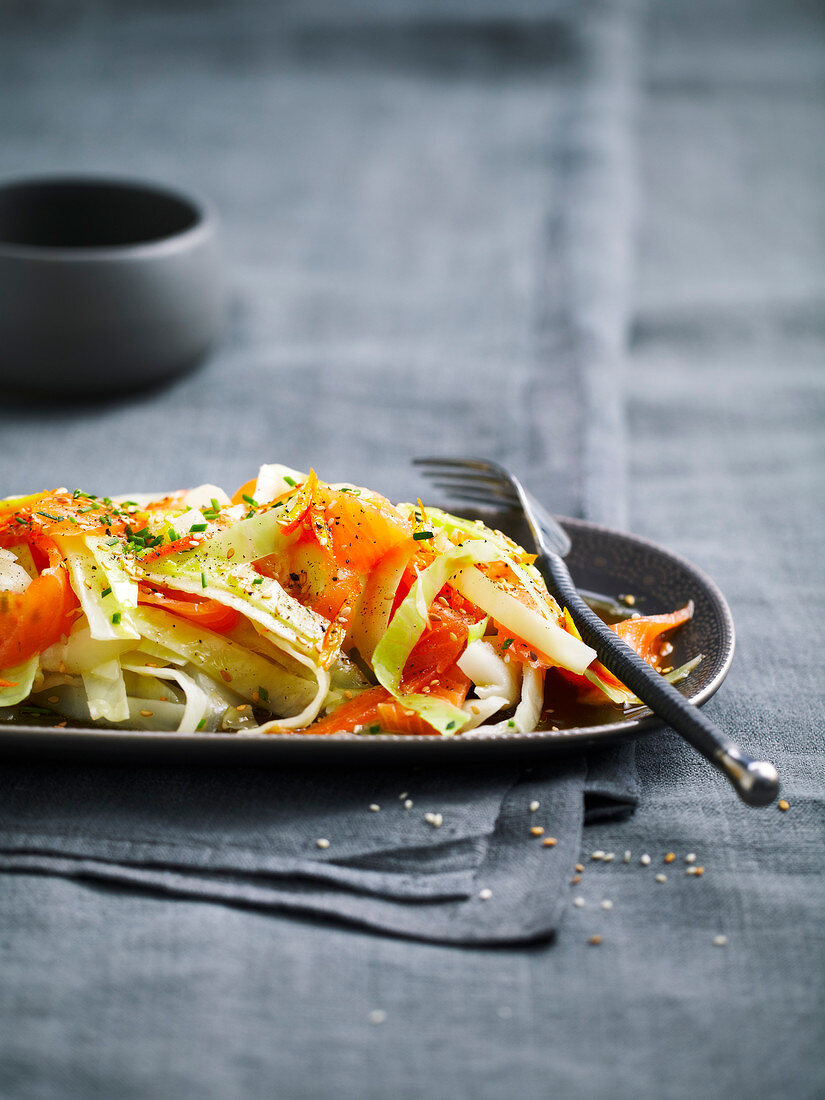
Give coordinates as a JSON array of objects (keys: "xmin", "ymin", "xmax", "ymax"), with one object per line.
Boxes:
[{"xmin": 536, "ymin": 553, "xmax": 779, "ymax": 806}]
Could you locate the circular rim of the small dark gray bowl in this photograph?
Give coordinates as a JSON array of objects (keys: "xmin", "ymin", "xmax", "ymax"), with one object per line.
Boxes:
[{"xmin": 0, "ymin": 172, "xmax": 218, "ymax": 263}]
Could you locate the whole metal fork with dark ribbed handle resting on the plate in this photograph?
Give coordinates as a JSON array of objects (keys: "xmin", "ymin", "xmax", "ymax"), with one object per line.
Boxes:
[{"xmin": 413, "ymin": 458, "xmax": 779, "ymax": 806}]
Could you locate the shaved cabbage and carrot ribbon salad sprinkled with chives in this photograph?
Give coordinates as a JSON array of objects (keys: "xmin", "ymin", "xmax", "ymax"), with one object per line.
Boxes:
[{"xmin": 0, "ymin": 465, "xmax": 697, "ymax": 737}]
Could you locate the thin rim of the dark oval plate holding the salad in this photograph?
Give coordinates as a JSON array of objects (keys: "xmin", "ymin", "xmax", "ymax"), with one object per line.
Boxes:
[{"xmin": 0, "ymin": 516, "xmax": 736, "ymax": 763}]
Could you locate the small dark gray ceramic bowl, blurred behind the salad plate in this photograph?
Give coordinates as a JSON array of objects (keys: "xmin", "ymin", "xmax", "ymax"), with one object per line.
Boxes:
[{"xmin": 0, "ymin": 177, "xmax": 222, "ymax": 396}]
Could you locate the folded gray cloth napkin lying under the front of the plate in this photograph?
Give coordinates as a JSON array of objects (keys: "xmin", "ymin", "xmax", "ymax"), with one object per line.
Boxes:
[{"xmin": 0, "ymin": 752, "xmax": 636, "ymax": 944}]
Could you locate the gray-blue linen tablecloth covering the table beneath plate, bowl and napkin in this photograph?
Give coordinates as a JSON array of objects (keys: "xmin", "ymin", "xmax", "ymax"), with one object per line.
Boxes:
[{"xmin": 0, "ymin": 0, "xmax": 825, "ymax": 1100}]
